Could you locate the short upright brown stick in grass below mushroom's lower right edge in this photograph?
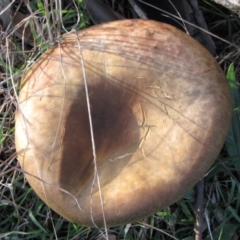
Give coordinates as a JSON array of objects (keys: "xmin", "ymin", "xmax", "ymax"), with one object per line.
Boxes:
[{"xmin": 194, "ymin": 178, "xmax": 204, "ymax": 240}]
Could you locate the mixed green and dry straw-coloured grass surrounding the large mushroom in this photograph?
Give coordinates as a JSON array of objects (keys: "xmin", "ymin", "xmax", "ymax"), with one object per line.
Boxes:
[{"xmin": 0, "ymin": 0, "xmax": 240, "ymax": 240}]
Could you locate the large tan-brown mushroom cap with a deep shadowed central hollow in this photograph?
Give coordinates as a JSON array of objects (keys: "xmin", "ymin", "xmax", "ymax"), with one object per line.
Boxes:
[{"xmin": 16, "ymin": 20, "xmax": 231, "ymax": 226}]
